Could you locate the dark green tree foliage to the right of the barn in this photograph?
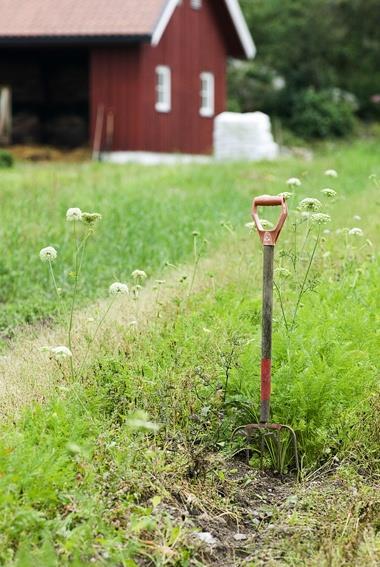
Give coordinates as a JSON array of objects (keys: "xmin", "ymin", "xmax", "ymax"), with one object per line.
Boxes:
[{"xmin": 230, "ymin": 0, "xmax": 380, "ymax": 137}]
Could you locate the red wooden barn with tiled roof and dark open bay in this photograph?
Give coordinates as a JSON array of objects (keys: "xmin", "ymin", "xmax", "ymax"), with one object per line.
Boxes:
[{"xmin": 0, "ymin": 0, "xmax": 255, "ymax": 154}]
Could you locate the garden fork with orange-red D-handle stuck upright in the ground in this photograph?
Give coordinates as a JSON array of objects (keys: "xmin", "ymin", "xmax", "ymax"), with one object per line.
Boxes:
[{"xmin": 233, "ymin": 195, "xmax": 299, "ymax": 472}]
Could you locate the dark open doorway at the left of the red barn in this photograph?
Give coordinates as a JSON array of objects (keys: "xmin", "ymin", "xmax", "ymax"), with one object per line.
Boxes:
[{"xmin": 0, "ymin": 46, "xmax": 89, "ymax": 148}]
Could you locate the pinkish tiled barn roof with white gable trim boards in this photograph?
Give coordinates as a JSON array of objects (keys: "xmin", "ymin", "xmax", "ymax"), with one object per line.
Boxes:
[{"xmin": 0, "ymin": 0, "xmax": 255, "ymax": 57}]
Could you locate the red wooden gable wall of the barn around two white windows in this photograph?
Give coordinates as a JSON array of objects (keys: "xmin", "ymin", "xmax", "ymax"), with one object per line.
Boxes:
[{"xmin": 90, "ymin": 0, "xmax": 227, "ymax": 153}]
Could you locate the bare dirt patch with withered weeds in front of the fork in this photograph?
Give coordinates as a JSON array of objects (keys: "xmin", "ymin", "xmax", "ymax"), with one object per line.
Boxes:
[{"xmin": 154, "ymin": 462, "xmax": 298, "ymax": 567}]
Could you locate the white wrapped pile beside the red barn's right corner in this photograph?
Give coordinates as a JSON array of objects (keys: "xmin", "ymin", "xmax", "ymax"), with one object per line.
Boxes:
[{"xmin": 214, "ymin": 112, "xmax": 279, "ymax": 160}]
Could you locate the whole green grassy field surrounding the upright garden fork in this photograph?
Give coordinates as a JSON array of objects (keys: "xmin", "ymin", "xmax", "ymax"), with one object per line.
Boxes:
[{"xmin": 0, "ymin": 140, "xmax": 380, "ymax": 567}]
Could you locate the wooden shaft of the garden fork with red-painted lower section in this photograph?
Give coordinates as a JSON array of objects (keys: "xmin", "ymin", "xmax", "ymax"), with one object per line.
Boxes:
[{"xmin": 260, "ymin": 245, "xmax": 274, "ymax": 423}]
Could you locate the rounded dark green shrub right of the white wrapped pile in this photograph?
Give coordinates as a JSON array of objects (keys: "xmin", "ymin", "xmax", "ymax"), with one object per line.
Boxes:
[{"xmin": 289, "ymin": 88, "xmax": 356, "ymax": 139}]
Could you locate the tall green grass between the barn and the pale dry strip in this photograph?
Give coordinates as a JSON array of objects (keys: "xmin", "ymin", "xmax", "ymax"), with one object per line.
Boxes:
[{"xmin": 0, "ymin": 141, "xmax": 379, "ymax": 337}]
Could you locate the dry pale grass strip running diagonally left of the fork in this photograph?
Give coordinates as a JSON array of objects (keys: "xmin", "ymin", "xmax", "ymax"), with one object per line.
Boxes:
[{"xmin": 0, "ymin": 235, "xmax": 253, "ymax": 418}]
